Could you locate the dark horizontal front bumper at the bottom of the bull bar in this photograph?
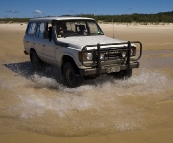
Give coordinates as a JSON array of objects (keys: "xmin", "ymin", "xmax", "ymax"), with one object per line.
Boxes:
[{"xmin": 79, "ymin": 61, "xmax": 140, "ymax": 76}]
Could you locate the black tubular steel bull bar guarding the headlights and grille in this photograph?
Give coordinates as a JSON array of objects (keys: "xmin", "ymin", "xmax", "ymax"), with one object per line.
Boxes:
[{"xmin": 81, "ymin": 41, "xmax": 142, "ymax": 75}]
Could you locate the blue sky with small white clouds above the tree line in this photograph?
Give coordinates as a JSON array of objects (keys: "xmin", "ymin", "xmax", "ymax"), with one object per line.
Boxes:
[{"xmin": 0, "ymin": 0, "xmax": 173, "ymax": 18}]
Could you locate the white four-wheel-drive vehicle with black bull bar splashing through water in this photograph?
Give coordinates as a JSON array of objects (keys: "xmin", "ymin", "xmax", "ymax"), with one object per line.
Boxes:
[{"xmin": 23, "ymin": 17, "xmax": 142, "ymax": 88}]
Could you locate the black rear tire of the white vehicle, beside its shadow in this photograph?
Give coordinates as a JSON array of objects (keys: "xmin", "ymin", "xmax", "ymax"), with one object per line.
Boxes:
[{"xmin": 31, "ymin": 52, "xmax": 43, "ymax": 72}]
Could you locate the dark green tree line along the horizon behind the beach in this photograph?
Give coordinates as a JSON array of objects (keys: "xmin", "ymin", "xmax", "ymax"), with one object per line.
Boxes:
[{"xmin": 0, "ymin": 11, "xmax": 173, "ymax": 24}]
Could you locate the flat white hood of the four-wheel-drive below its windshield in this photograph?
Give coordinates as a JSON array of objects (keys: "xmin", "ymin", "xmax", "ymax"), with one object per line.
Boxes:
[{"xmin": 58, "ymin": 35, "xmax": 127, "ymax": 49}]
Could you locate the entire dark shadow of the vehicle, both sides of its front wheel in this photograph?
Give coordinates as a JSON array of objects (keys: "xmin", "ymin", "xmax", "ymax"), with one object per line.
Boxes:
[{"xmin": 4, "ymin": 61, "xmax": 112, "ymax": 86}]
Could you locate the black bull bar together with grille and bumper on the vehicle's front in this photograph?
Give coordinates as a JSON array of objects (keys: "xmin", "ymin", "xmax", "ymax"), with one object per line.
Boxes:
[{"xmin": 79, "ymin": 41, "xmax": 142, "ymax": 76}]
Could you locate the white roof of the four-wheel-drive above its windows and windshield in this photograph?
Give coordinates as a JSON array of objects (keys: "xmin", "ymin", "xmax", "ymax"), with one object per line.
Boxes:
[{"xmin": 30, "ymin": 17, "xmax": 94, "ymax": 22}]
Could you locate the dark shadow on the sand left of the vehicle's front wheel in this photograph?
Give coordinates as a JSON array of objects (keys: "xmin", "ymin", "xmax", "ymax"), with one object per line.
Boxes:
[{"xmin": 4, "ymin": 61, "xmax": 63, "ymax": 84}]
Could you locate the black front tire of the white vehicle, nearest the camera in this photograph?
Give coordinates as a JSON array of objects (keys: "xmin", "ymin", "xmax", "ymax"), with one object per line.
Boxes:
[{"xmin": 63, "ymin": 62, "xmax": 84, "ymax": 88}]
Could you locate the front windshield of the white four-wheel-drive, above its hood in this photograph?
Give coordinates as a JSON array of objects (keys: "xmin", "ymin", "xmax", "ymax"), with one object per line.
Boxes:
[{"xmin": 56, "ymin": 20, "xmax": 103, "ymax": 38}]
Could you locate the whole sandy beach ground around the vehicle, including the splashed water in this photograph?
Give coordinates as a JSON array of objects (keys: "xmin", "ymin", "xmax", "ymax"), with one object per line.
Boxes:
[{"xmin": 0, "ymin": 24, "xmax": 173, "ymax": 143}]
